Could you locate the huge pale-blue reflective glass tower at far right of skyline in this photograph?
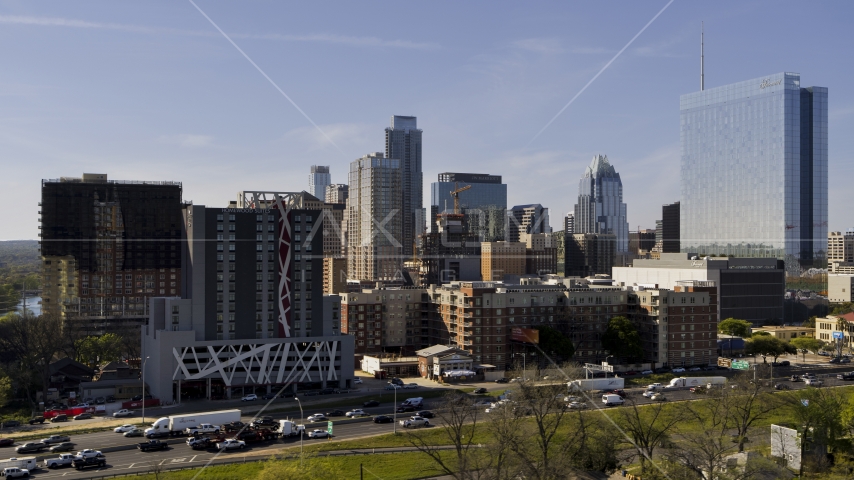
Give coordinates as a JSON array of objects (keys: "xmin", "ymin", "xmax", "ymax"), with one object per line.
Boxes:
[{"xmin": 679, "ymin": 73, "xmax": 827, "ymax": 274}]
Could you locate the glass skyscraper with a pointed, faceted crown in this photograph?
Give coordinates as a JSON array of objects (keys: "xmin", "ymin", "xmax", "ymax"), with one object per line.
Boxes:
[{"xmin": 574, "ymin": 155, "xmax": 629, "ymax": 253}]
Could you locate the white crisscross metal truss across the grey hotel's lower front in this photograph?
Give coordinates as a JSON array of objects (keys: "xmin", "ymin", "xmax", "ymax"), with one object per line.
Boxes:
[{"xmin": 172, "ymin": 340, "xmax": 340, "ymax": 387}]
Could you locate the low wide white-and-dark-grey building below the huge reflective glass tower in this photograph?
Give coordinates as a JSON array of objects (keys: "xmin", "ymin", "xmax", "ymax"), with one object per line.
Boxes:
[{"xmin": 611, "ymin": 253, "xmax": 786, "ymax": 326}]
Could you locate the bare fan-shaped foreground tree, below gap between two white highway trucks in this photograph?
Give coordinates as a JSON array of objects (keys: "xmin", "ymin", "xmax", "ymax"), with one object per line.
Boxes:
[{"xmin": 614, "ymin": 397, "xmax": 683, "ymax": 475}]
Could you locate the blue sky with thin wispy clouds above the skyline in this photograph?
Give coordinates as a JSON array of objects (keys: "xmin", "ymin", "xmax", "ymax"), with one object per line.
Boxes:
[{"xmin": 0, "ymin": 0, "xmax": 854, "ymax": 239}]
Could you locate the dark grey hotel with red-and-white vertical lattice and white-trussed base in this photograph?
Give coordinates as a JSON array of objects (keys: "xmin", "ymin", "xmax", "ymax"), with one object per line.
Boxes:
[{"xmin": 142, "ymin": 191, "xmax": 353, "ymax": 401}]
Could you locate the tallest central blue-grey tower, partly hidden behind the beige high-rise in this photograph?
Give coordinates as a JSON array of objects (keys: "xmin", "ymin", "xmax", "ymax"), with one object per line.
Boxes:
[{"xmin": 386, "ymin": 115, "xmax": 424, "ymax": 257}]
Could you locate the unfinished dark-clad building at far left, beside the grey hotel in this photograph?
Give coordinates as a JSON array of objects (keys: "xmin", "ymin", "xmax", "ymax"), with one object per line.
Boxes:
[{"xmin": 39, "ymin": 174, "xmax": 184, "ymax": 335}]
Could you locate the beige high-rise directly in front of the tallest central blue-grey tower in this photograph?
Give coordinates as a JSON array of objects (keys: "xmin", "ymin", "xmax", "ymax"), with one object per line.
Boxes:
[{"xmin": 347, "ymin": 153, "xmax": 402, "ymax": 282}]
